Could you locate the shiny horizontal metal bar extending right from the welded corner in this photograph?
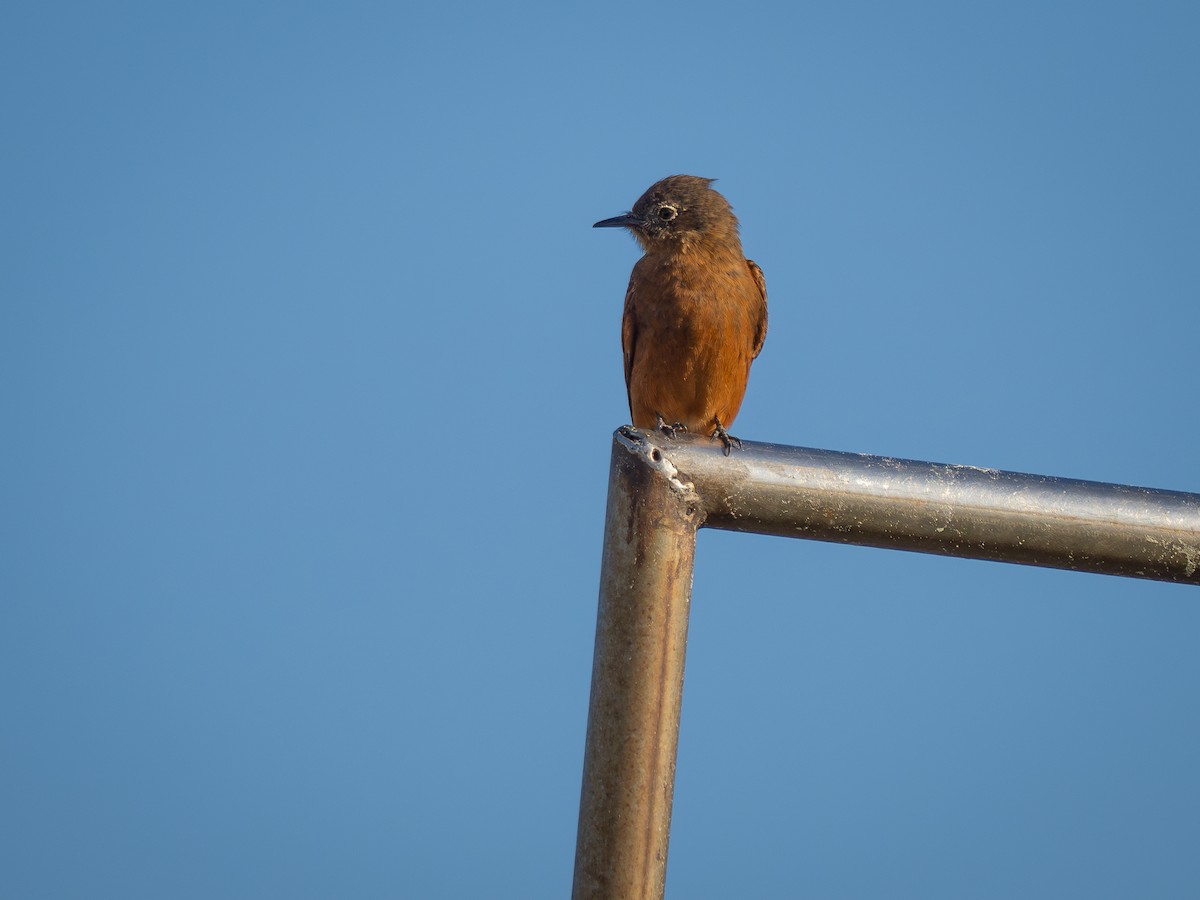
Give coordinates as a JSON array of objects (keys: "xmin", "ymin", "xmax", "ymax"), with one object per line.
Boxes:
[{"xmin": 616, "ymin": 428, "xmax": 1200, "ymax": 584}]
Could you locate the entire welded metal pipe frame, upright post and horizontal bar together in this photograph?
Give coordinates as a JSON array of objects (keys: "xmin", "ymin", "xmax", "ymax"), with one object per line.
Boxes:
[{"xmin": 572, "ymin": 428, "xmax": 1200, "ymax": 900}]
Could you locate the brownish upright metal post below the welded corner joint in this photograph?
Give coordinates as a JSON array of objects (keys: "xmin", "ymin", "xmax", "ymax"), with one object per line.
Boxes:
[{"xmin": 571, "ymin": 432, "xmax": 703, "ymax": 900}]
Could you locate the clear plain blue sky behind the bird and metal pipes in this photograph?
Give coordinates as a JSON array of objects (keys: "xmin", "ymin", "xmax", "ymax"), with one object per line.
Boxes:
[{"xmin": 0, "ymin": 1, "xmax": 1200, "ymax": 900}]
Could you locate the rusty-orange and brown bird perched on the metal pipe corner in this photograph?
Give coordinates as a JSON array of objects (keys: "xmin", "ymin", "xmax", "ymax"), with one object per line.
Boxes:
[{"xmin": 592, "ymin": 175, "xmax": 767, "ymax": 456}]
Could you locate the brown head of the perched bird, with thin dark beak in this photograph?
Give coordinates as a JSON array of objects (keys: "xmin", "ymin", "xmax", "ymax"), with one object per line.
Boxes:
[{"xmin": 592, "ymin": 175, "xmax": 738, "ymax": 252}]
